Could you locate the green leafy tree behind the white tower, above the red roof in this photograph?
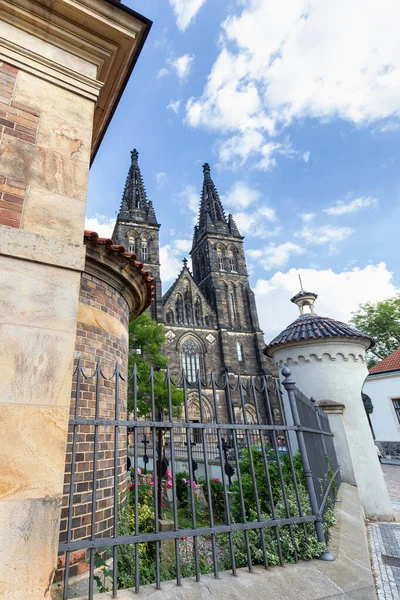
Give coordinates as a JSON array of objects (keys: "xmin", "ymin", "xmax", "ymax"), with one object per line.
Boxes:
[{"xmin": 350, "ymin": 294, "xmax": 400, "ymax": 367}]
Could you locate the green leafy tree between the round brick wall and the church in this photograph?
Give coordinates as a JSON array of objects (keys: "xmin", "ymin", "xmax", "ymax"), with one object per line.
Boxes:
[{"xmin": 128, "ymin": 313, "xmax": 183, "ymax": 417}]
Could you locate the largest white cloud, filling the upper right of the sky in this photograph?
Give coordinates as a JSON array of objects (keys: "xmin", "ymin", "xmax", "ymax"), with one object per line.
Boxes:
[{"xmin": 186, "ymin": 0, "xmax": 400, "ymax": 168}]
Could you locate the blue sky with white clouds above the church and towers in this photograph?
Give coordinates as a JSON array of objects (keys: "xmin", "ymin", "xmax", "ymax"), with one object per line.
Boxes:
[{"xmin": 87, "ymin": 0, "xmax": 400, "ymax": 340}]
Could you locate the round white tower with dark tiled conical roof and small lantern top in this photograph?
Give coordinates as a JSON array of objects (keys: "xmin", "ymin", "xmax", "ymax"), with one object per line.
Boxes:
[{"xmin": 264, "ymin": 291, "xmax": 393, "ymax": 520}]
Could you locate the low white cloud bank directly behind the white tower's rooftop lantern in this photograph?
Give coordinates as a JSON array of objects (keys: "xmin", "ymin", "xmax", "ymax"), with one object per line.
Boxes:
[{"xmin": 254, "ymin": 263, "xmax": 399, "ymax": 342}]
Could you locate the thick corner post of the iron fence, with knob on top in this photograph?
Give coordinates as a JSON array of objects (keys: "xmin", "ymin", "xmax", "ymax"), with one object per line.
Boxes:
[{"xmin": 282, "ymin": 367, "xmax": 335, "ymax": 561}]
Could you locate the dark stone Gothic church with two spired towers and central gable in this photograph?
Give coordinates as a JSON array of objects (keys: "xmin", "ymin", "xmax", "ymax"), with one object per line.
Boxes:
[{"xmin": 113, "ymin": 150, "xmax": 271, "ymax": 419}]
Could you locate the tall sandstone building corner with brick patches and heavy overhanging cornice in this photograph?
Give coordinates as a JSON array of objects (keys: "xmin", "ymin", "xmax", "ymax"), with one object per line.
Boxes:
[{"xmin": 0, "ymin": 0, "xmax": 149, "ymax": 600}]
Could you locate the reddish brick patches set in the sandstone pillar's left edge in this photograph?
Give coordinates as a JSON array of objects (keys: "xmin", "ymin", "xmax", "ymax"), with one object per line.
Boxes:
[{"xmin": 0, "ymin": 61, "xmax": 40, "ymax": 228}]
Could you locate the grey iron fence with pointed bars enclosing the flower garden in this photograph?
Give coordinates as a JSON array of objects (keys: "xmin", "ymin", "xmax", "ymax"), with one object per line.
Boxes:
[{"xmin": 58, "ymin": 360, "xmax": 340, "ymax": 600}]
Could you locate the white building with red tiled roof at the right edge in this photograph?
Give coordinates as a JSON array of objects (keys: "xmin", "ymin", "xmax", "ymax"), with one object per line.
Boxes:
[{"xmin": 363, "ymin": 348, "xmax": 400, "ymax": 459}]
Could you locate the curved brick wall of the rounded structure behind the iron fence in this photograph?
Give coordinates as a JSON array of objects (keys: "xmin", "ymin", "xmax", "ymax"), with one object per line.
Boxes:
[{"xmin": 57, "ymin": 273, "xmax": 129, "ymax": 580}]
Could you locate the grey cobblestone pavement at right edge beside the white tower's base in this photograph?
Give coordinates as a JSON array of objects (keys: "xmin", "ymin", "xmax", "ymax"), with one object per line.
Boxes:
[{"xmin": 368, "ymin": 464, "xmax": 400, "ymax": 600}]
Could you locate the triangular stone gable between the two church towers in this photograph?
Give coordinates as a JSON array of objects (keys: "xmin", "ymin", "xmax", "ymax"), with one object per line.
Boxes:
[{"xmin": 163, "ymin": 262, "xmax": 216, "ymax": 328}]
